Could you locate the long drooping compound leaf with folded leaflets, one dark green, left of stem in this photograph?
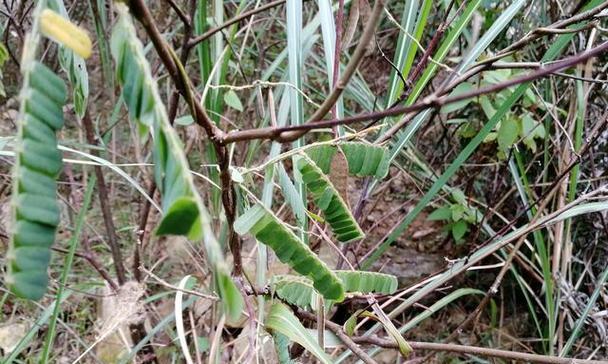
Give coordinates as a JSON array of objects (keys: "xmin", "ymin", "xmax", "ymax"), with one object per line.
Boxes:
[{"xmin": 111, "ymin": 3, "xmax": 243, "ymax": 319}]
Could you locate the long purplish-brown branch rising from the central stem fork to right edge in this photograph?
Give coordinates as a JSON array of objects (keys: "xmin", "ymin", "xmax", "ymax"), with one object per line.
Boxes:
[{"xmin": 222, "ymin": 42, "xmax": 608, "ymax": 144}]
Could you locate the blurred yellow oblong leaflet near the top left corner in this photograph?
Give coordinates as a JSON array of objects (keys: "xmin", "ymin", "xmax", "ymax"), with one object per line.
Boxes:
[{"xmin": 40, "ymin": 9, "xmax": 93, "ymax": 58}]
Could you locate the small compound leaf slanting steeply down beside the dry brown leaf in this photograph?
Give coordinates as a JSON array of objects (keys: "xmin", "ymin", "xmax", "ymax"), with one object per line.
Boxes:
[{"xmin": 296, "ymin": 155, "xmax": 365, "ymax": 243}]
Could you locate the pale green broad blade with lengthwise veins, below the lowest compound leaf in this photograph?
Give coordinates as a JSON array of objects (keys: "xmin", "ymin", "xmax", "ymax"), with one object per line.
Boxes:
[{"xmin": 264, "ymin": 303, "xmax": 332, "ymax": 364}]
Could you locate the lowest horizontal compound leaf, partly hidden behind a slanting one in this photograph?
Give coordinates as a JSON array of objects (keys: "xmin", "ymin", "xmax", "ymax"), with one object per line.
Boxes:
[{"xmin": 270, "ymin": 270, "xmax": 397, "ymax": 309}]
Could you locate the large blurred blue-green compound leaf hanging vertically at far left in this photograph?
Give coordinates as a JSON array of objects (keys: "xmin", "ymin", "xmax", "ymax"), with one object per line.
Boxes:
[{"xmin": 5, "ymin": 4, "xmax": 66, "ymax": 300}]
